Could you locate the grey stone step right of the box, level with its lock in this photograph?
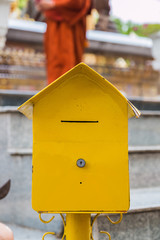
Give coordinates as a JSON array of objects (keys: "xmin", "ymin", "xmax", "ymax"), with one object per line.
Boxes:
[{"xmin": 129, "ymin": 146, "xmax": 160, "ymax": 188}]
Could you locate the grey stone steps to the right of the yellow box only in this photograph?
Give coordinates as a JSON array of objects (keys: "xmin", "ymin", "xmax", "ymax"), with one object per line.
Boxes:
[{"xmin": 95, "ymin": 111, "xmax": 160, "ymax": 240}]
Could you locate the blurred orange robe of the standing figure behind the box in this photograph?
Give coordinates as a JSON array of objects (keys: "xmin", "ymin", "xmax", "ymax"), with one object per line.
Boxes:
[{"xmin": 45, "ymin": 0, "xmax": 91, "ymax": 84}]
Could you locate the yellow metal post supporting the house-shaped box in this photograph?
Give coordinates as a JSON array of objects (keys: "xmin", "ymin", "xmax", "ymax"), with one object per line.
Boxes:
[{"xmin": 65, "ymin": 213, "xmax": 91, "ymax": 240}]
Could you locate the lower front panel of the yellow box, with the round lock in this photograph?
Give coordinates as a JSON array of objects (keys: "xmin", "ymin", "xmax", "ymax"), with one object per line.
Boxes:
[{"xmin": 32, "ymin": 142, "xmax": 129, "ymax": 212}]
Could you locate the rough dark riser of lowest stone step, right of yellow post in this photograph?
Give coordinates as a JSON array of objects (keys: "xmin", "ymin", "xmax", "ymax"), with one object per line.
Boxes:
[{"xmin": 94, "ymin": 210, "xmax": 160, "ymax": 240}]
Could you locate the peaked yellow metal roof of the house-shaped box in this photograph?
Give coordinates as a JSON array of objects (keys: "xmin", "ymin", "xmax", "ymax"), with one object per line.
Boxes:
[{"xmin": 18, "ymin": 63, "xmax": 141, "ymax": 119}]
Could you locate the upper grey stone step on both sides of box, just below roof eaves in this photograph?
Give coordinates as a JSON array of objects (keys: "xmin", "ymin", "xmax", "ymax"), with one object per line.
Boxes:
[{"xmin": 0, "ymin": 106, "xmax": 160, "ymax": 149}]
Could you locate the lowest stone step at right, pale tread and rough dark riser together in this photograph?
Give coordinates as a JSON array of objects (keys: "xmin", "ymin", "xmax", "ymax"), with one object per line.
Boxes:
[{"xmin": 94, "ymin": 188, "xmax": 160, "ymax": 240}]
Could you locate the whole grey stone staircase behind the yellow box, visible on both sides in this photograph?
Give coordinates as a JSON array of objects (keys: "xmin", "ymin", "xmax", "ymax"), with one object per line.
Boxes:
[{"xmin": 0, "ymin": 96, "xmax": 160, "ymax": 240}]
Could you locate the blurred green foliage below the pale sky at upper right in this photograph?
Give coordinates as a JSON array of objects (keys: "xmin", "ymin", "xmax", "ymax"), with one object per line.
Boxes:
[{"xmin": 113, "ymin": 18, "xmax": 160, "ymax": 37}]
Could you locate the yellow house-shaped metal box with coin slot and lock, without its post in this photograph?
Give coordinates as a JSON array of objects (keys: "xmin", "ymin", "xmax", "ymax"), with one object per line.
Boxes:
[{"xmin": 19, "ymin": 63, "xmax": 140, "ymax": 213}]
